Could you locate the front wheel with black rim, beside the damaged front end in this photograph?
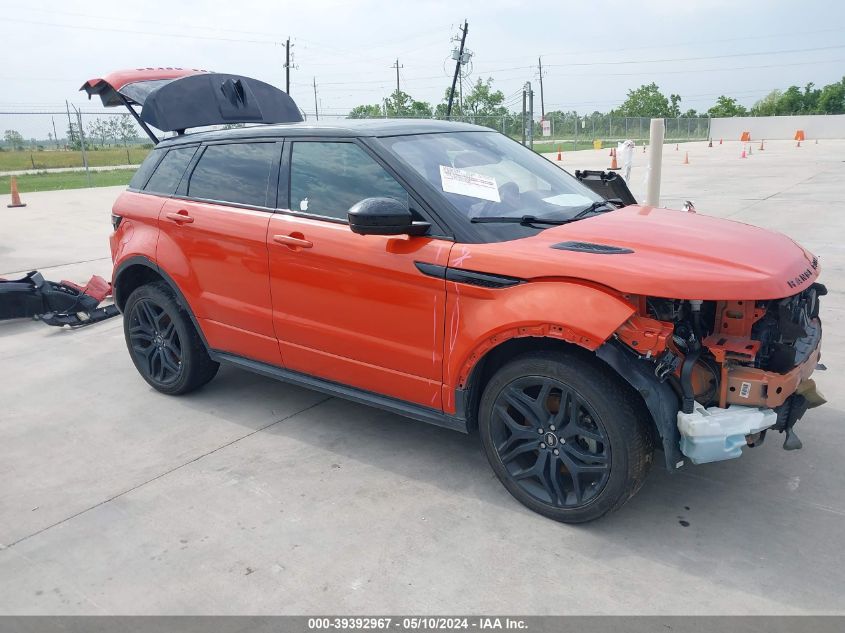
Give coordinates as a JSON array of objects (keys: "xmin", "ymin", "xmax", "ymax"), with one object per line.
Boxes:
[{"xmin": 478, "ymin": 352, "xmax": 654, "ymax": 523}]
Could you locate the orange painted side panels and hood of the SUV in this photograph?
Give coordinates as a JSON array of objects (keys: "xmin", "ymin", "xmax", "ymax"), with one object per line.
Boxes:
[{"xmin": 112, "ymin": 192, "xmax": 818, "ymax": 413}]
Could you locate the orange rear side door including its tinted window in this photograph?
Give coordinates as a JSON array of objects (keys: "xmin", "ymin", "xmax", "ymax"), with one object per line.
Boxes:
[{"xmin": 157, "ymin": 140, "xmax": 282, "ymax": 365}]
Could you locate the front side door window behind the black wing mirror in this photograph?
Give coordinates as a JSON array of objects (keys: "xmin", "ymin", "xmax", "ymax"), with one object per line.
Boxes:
[{"xmin": 290, "ymin": 142, "xmax": 408, "ymax": 220}]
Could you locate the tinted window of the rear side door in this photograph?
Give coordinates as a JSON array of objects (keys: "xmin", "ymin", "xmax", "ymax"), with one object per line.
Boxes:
[{"xmin": 188, "ymin": 143, "xmax": 280, "ymax": 207}]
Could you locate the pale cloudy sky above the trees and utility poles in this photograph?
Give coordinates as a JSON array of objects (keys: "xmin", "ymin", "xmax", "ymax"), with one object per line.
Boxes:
[{"xmin": 0, "ymin": 0, "xmax": 845, "ymax": 127}]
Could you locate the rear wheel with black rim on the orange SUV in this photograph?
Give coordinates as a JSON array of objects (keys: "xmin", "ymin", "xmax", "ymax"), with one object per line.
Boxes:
[{"xmin": 123, "ymin": 281, "xmax": 220, "ymax": 395}]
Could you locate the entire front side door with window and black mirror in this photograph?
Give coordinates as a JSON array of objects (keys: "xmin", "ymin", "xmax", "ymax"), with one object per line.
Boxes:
[{"xmin": 267, "ymin": 141, "xmax": 452, "ymax": 409}]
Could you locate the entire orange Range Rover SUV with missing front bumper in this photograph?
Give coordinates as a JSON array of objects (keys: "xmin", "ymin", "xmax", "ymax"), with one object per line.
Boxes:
[{"xmin": 83, "ymin": 69, "xmax": 826, "ymax": 522}]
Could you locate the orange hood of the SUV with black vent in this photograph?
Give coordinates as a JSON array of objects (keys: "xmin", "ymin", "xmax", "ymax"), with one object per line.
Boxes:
[{"xmin": 454, "ymin": 205, "xmax": 819, "ymax": 301}]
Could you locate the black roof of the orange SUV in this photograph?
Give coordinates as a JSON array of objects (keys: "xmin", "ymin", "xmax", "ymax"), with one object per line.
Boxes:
[{"xmin": 161, "ymin": 119, "xmax": 492, "ymax": 147}]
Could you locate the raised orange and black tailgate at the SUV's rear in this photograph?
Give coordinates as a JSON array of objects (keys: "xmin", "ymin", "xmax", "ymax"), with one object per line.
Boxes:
[{"xmin": 80, "ymin": 68, "xmax": 302, "ymax": 143}]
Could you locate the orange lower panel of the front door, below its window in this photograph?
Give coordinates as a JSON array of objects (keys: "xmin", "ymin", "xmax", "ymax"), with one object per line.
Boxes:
[{"xmin": 267, "ymin": 213, "xmax": 452, "ymax": 409}]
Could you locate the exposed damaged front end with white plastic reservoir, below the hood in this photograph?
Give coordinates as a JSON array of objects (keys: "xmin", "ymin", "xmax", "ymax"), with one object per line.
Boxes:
[{"xmin": 599, "ymin": 283, "xmax": 827, "ymax": 470}]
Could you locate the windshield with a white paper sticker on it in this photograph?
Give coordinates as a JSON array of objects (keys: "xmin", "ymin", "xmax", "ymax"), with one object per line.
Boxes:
[{"xmin": 382, "ymin": 132, "xmax": 602, "ymax": 241}]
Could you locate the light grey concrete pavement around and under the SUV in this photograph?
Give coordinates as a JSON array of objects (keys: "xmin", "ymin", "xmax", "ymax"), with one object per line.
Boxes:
[{"xmin": 0, "ymin": 141, "xmax": 845, "ymax": 614}]
